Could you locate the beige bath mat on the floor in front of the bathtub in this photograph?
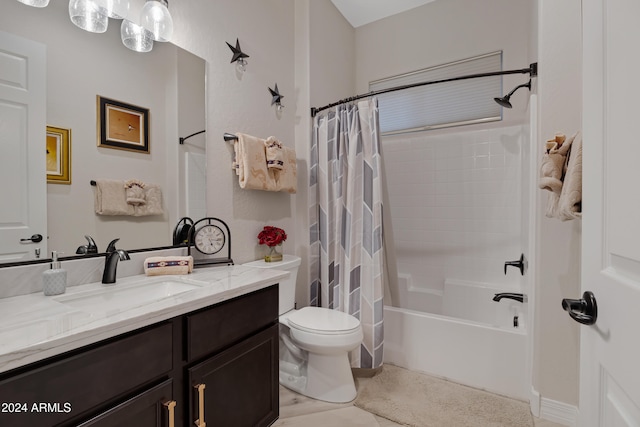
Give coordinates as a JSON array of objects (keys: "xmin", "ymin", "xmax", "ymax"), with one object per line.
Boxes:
[{"xmin": 354, "ymin": 364, "xmax": 533, "ymax": 427}]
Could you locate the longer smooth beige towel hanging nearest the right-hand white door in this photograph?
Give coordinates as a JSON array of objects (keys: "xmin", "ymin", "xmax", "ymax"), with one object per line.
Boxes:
[{"xmin": 558, "ymin": 132, "xmax": 582, "ymax": 221}]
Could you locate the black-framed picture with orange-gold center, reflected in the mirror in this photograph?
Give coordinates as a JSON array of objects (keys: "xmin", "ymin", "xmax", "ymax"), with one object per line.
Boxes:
[{"xmin": 97, "ymin": 95, "xmax": 149, "ymax": 154}]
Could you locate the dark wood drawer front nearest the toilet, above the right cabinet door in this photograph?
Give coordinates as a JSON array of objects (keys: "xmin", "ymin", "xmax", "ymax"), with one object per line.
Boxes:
[{"xmin": 187, "ymin": 285, "xmax": 278, "ymax": 362}]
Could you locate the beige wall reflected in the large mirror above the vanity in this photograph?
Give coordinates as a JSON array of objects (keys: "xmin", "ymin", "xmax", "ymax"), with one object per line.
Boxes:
[{"xmin": 0, "ymin": 0, "xmax": 206, "ymax": 266}]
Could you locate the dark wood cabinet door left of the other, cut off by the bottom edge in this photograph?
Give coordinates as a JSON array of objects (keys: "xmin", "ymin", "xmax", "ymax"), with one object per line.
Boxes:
[{"xmin": 78, "ymin": 380, "xmax": 176, "ymax": 427}]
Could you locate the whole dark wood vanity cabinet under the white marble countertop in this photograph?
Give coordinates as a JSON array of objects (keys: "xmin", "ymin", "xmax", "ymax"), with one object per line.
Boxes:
[{"xmin": 0, "ymin": 285, "xmax": 279, "ymax": 427}]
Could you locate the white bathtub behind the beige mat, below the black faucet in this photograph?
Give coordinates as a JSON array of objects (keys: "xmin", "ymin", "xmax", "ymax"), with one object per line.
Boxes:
[{"xmin": 384, "ymin": 279, "xmax": 529, "ymax": 400}]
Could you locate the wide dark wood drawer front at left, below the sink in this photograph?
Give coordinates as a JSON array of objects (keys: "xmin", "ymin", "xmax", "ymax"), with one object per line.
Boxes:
[{"xmin": 0, "ymin": 323, "xmax": 173, "ymax": 427}]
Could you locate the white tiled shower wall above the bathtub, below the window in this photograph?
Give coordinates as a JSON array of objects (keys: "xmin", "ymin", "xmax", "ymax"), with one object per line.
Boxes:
[{"xmin": 382, "ymin": 126, "xmax": 528, "ymax": 313}]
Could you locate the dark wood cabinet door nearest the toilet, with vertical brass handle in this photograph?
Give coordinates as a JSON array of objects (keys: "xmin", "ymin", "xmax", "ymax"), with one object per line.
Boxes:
[{"xmin": 187, "ymin": 324, "xmax": 279, "ymax": 427}]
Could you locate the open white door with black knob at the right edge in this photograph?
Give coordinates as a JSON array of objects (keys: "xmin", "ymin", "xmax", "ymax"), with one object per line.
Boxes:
[{"xmin": 579, "ymin": 0, "xmax": 640, "ymax": 427}]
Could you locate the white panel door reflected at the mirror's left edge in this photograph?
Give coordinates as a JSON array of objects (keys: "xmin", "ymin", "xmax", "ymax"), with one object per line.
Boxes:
[{"xmin": 0, "ymin": 32, "xmax": 47, "ymax": 262}]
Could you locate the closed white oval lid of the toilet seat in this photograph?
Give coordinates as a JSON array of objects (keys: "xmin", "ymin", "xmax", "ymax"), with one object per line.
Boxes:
[{"xmin": 289, "ymin": 307, "xmax": 360, "ymax": 334}]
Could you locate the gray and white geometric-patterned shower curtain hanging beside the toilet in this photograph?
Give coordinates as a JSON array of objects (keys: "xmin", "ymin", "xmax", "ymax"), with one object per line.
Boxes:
[{"xmin": 309, "ymin": 98, "xmax": 384, "ymax": 368}]
